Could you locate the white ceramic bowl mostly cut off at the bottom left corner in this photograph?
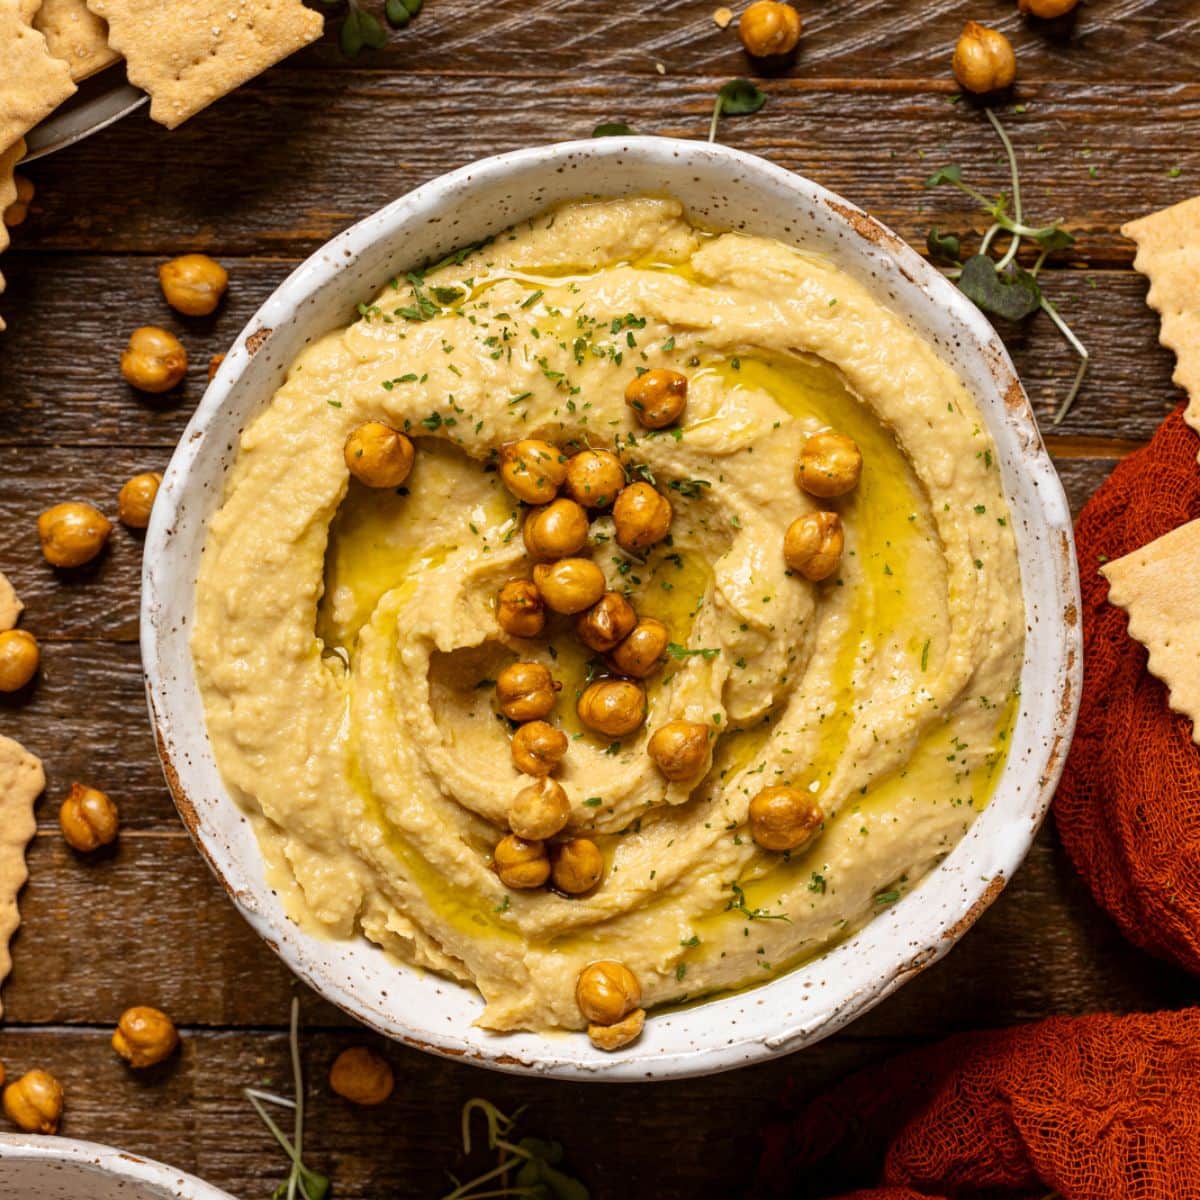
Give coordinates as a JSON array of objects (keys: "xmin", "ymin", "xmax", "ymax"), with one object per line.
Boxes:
[{"xmin": 0, "ymin": 1134, "xmax": 234, "ymax": 1200}]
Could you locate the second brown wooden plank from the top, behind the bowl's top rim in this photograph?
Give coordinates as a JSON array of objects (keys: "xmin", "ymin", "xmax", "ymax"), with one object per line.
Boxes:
[{"xmin": 8, "ymin": 75, "xmax": 1200, "ymax": 262}]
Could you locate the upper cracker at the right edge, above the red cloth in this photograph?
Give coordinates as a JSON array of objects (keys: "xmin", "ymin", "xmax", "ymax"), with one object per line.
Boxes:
[{"xmin": 1121, "ymin": 196, "xmax": 1200, "ymax": 441}]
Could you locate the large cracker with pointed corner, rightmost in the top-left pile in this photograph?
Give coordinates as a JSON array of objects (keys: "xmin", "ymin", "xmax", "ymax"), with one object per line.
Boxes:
[{"xmin": 88, "ymin": 0, "xmax": 324, "ymax": 128}]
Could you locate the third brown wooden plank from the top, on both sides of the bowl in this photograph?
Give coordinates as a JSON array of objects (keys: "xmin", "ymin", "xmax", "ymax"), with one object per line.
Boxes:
[{"xmin": 0, "ymin": 253, "xmax": 1181, "ymax": 451}]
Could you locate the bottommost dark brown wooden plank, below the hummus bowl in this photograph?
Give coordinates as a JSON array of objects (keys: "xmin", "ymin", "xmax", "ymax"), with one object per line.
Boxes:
[{"xmin": 0, "ymin": 1030, "xmax": 899, "ymax": 1200}]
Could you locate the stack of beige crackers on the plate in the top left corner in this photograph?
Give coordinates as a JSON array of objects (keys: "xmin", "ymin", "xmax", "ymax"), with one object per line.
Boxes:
[{"xmin": 0, "ymin": 0, "xmax": 324, "ymax": 329}]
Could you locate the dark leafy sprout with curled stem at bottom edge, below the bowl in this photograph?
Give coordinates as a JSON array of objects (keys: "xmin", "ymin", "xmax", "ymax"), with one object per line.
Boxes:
[{"xmin": 442, "ymin": 1097, "xmax": 589, "ymax": 1200}]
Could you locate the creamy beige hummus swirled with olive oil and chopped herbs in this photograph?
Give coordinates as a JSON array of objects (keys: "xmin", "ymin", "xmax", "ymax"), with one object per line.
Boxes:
[{"xmin": 192, "ymin": 198, "xmax": 1024, "ymax": 1030}]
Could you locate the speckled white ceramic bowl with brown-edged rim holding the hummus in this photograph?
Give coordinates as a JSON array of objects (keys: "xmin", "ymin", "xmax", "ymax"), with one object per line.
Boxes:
[{"xmin": 142, "ymin": 137, "xmax": 1081, "ymax": 1080}]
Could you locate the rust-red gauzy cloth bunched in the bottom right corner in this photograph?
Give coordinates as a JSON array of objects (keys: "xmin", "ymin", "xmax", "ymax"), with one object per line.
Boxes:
[{"xmin": 755, "ymin": 1008, "xmax": 1200, "ymax": 1200}]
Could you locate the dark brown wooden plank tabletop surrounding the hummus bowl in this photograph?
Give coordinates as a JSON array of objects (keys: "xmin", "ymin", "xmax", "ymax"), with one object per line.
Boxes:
[{"xmin": 0, "ymin": 0, "xmax": 1200, "ymax": 1200}]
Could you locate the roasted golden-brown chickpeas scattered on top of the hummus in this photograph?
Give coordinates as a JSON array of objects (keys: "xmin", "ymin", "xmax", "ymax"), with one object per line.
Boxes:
[{"xmin": 345, "ymin": 357, "xmax": 863, "ymax": 1051}]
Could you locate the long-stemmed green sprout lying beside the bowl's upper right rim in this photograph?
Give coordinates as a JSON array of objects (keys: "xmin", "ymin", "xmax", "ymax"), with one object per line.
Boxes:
[{"xmin": 925, "ymin": 108, "xmax": 1090, "ymax": 425}]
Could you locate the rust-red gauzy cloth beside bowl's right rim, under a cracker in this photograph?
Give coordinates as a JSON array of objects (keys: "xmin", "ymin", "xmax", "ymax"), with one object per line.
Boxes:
[{"xmin": 1054, "ymin": 406, "xmax": 1200, "ymax": 973}]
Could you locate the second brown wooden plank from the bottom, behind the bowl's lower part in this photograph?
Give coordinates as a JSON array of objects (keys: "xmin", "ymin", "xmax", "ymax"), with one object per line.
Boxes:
[{"xmin": 7, "ymin": 802, "xmax": 1198, "ymax": 1027}]
